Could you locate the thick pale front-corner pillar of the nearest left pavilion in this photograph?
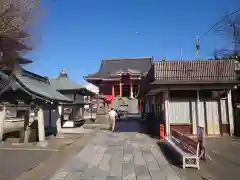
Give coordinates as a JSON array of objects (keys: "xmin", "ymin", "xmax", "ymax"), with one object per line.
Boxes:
[{"xmin": 37, "ymin": 107, "xmax": 48, "ymax": 147}]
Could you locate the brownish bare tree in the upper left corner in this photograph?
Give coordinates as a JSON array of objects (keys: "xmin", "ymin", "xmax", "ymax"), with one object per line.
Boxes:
[{"xmin": 0, "ymin": 0, "xmax": 40, "ymax": 69}]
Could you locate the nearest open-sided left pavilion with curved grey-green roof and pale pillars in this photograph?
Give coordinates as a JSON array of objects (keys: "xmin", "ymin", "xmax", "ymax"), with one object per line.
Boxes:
[{"xmin": 0, "ymin": 67, "xmax": 72, "ymax": 146}]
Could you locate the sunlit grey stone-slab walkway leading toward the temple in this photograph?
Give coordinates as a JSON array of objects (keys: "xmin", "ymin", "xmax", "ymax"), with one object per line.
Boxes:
[{"xmin": 49, "ymin": 131, "xmax": 184, "ymax": 180}]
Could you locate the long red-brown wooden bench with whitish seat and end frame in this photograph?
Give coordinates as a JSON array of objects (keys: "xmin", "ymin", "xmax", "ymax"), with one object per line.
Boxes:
[{"xmin": 165, "ymin": 129, "xmax": 200, "ymax": 169}]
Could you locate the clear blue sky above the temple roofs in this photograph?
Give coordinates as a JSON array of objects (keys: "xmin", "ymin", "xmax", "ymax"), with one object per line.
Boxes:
[{"xmin": 26, "ymin": 0, "xmax": 240, "ymax": 83}]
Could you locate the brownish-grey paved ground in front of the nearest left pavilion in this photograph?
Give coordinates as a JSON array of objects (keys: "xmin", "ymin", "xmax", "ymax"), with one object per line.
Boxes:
[{"xmin": 0, "ymin": 135, "xmax": 84, "ymax": 180}]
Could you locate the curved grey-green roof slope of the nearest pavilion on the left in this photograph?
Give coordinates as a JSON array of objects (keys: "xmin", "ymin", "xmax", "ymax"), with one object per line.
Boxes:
[{"xmin": 14, "ymin": 69, "xmax": 73, "ymax": 102}]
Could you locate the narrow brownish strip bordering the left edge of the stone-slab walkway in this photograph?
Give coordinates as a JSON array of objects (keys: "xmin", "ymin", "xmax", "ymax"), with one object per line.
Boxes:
[{"xmin": 16, "ymin": 128, "xmax": 100, "ymax": 180}]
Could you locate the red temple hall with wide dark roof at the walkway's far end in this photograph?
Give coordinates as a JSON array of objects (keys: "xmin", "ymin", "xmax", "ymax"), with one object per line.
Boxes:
[{"xmin": 84, "ymin": 57, "xmax": 153, "ymax": 101}]
